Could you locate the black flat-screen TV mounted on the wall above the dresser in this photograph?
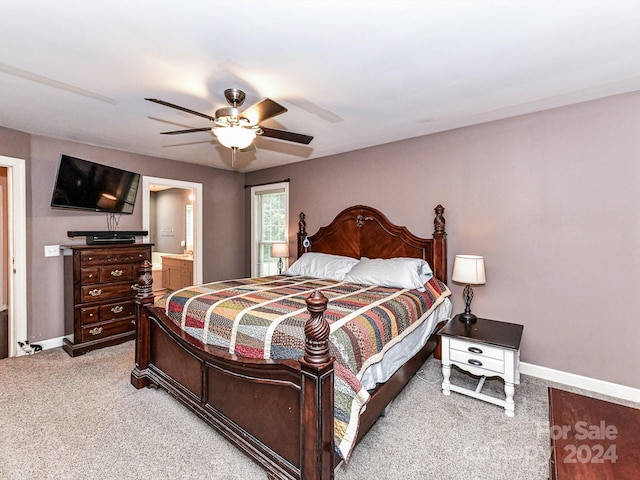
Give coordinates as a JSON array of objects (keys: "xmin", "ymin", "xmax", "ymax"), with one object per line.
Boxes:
[{"xmin": 51, "ymin": 155, "xmax": 140, "ymax": 214}]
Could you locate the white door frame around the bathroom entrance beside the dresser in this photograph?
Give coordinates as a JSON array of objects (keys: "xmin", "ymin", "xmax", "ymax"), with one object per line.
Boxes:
[{"xmin": 142, "ymin": 175, "xmax": 203, "ymax": 285}]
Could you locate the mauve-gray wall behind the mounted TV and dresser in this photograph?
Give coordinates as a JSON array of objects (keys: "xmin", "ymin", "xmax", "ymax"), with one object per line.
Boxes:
[{"xmin": 0, "ymin": 127, "xmax": 245, "ymax": 342}]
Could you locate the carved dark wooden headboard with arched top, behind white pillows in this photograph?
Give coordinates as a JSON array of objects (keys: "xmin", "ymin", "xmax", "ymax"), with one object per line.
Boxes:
[{"xmin": 298, "ymin": 205, "xmax": 447, "ymax": 283}]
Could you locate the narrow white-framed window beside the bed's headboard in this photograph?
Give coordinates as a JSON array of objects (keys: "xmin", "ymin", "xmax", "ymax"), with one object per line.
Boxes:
[{"xmin": 251, "ymin": 182, "xmax": 289, "ymax": 277}]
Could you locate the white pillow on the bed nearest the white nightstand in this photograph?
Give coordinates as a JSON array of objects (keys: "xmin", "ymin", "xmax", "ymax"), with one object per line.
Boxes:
[{"xmin": 344, "ymin": 257, "xmax": 433, "ymax": 292}]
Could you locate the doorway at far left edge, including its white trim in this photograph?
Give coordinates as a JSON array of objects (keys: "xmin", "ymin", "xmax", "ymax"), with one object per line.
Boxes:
[{"xmin": 0, "ymin": 156, "xmax": 27, "ymax": 357}]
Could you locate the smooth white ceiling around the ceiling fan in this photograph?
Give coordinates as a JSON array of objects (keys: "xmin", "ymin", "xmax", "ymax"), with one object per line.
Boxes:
[{"xmin": 0, "ymin": 0, "xmax": 640, "ymax": 171}]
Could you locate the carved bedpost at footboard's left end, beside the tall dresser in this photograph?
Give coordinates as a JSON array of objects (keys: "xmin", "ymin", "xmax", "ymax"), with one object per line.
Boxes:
[{"xmin": 131, "ymin": 260, "xmax": 154, "ymax": 388}]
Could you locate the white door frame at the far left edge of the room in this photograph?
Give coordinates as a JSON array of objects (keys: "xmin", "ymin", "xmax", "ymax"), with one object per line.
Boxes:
[{"xmin": 0, "ymin": 155, "xmax": 27, "ymax": 357}]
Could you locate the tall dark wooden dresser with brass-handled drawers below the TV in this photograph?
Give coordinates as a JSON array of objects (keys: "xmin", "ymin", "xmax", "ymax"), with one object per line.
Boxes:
[{"xmin": 62, "ymin": 243, "xmax": 152, "ymax": 357}]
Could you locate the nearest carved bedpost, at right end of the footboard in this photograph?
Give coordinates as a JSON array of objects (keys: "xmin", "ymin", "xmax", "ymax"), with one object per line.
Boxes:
[{"xmin": 300, "ymin": 291, "xmax": 334, "ymax": 480}]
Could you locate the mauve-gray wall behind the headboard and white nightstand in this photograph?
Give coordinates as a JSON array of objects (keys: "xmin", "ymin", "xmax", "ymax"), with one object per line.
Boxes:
[{"xmin": 246, "ymin": 93, "xmax": 640, "ymax": 388}]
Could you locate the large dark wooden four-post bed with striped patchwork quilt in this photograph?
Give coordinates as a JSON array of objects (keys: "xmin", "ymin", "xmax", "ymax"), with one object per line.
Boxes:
[{"xmin": 131, "ymin": 205, "xmax": 450, "ymax": 480}]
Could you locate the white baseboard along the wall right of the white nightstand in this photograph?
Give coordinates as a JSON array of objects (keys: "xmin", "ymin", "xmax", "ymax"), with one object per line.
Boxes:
[{"xmin": 520, "ymin": 362, "xmax": 640, "ymax": 403}]
